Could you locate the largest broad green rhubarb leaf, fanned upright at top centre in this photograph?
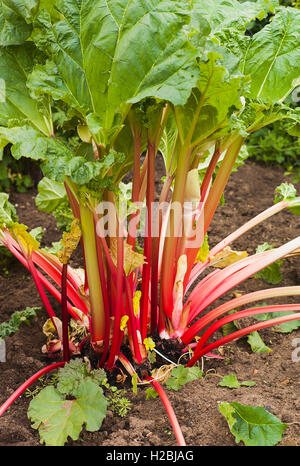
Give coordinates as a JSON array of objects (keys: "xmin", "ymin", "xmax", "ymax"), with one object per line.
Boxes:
[{"xmin": 33, "ymin": 0, "xmax": 202, "ymax": 138}]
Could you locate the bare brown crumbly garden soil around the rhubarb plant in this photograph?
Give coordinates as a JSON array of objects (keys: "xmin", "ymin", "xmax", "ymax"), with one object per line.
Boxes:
[{"xmin": 0, "ymin": 162, "xmax": 300, "ymax": 446}]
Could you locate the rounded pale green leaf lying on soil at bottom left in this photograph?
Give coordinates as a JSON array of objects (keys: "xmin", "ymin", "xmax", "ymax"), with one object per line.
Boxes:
[{"xmin": 28, "ymin": 380, "xmax": 107, "ymax": 446}]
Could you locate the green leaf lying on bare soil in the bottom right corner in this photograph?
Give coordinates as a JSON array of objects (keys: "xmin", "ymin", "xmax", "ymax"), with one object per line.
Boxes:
[{"xmin": 219, "ymin": 402, "xmax": 288, "ymax": 446}]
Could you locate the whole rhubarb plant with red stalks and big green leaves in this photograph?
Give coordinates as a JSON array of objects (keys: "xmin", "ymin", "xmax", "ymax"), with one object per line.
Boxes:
[{"xmin": 0, "ymin": 0, "xmax": 300, "ymax": 442}]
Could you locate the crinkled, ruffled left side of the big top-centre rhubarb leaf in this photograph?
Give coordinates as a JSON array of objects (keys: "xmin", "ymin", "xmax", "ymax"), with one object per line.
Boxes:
[{"xmin": 29, "ymin": 5, "xmax": 94, "ymax": 115}]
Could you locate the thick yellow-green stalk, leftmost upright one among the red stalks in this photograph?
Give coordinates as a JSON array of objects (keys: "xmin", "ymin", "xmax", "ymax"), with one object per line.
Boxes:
[{"xmin": 80, "ymin": 203, "xmax": 105, "ymax": 344}]
